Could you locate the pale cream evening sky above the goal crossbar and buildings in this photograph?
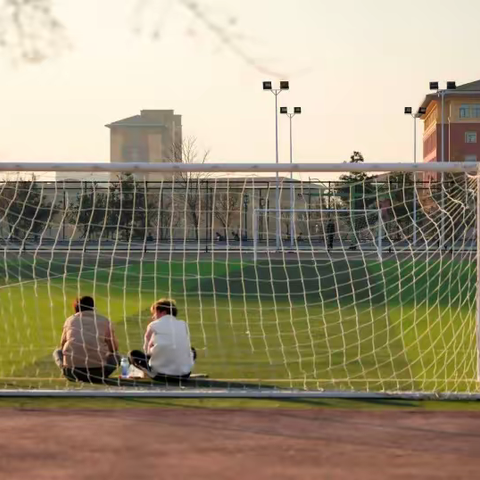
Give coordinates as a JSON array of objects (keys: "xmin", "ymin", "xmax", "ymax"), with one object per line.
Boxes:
[{"xmin": 0, "ymin": 0, "xmax": 480, "ymax": 169}]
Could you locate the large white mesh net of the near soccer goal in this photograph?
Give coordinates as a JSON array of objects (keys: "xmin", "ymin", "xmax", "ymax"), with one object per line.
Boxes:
[{"xmin": 0, "ymin": 164, "xmax": 480, "ymax": 396}]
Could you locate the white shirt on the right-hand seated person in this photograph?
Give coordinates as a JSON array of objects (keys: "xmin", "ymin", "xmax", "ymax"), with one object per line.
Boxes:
[{"xmin": 144, "ymin": 315, "xmax": 194, "ymax": 376}]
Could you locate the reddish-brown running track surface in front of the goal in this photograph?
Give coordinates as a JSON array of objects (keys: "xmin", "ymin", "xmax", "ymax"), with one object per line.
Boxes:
[{"xmin": 0, "ymin": 409, "xmax": 480, "ymax": 480}]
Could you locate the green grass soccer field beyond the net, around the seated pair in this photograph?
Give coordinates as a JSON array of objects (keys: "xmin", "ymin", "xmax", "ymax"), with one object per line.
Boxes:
[{"xmin": 0, "ymin": 256, "xmax": 477, "ymax": 392}]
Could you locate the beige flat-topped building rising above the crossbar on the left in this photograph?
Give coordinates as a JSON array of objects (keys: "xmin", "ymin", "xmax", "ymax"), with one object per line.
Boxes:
[{"xmin": 106, "ymin": 110, "xmax": 182, "ymax": 163}]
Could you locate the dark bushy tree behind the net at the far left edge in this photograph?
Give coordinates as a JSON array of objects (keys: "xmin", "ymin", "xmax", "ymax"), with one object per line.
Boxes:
[{"xmin": 0, "ymin": 175, "xmax": 57, "ymax": 241}]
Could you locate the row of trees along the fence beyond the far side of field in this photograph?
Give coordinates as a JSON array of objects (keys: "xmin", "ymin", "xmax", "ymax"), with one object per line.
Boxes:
[{"xmin": 0, "ymin": 152, "xmax": 468, "ymax": 246}]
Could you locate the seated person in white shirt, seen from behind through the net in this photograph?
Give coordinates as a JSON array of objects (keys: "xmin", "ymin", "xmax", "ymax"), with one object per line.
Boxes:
[{"xmin": 129, "ymin": 298, "xmax": 196, "ymax": 380}]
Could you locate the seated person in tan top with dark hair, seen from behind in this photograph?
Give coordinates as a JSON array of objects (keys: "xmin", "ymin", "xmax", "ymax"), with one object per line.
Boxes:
[{"xmin": 53, "ymin": 297, "xmax": 121, "ymax": 383}]
